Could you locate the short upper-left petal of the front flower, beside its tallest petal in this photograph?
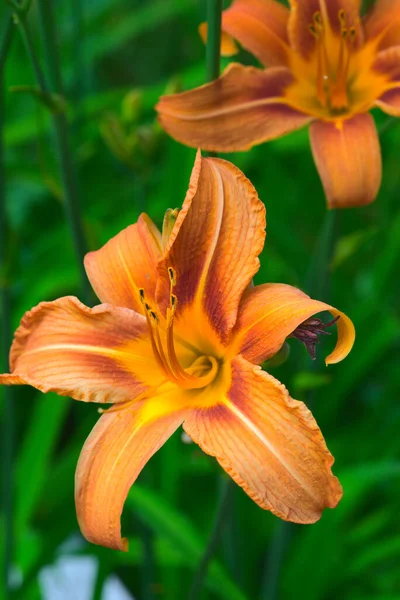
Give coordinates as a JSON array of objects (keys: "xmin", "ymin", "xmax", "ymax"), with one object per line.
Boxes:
[{"xmin": 85, "ymin": 215, "xmax": 161, "ymax": 313}]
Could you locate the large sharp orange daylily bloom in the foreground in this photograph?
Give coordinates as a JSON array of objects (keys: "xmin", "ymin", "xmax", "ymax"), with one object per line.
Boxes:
[{"xmin": 0, "ymin": 153, "xmax": 354, "ymax": 550}]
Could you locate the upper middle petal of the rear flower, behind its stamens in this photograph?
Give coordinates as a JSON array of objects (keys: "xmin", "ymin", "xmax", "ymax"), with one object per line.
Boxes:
[{"xmin": 288, "ymin": 0, "xmax": 364, "ymax": 57}]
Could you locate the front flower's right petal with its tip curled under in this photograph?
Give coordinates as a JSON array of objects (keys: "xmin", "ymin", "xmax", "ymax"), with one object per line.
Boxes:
[{"xmin": 235, "ymin": 283, "xmax": 355, "ymax": 365}]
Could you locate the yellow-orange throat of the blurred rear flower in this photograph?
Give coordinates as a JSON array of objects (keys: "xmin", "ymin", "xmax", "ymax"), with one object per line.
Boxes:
[{"xmin": 284, "ymin": 0, "xmax": 390, "ymax": 124}]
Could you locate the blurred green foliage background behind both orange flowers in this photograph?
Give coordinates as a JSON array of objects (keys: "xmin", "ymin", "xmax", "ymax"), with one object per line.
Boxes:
[{"xmin": 0, "ymin": 0, "xmax": 400, "ymax": 600}]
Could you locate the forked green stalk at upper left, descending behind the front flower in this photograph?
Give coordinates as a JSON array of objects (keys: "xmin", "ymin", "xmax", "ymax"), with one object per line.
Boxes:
[{"xmin": 15, "ymin": 0, "xmax": 92, "ymax": 302}]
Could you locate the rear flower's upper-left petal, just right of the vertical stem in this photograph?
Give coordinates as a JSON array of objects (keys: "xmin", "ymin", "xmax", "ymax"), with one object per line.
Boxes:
[{"xmin": 199, "ymin": 0, "xmax": 289, "ymax": 67}]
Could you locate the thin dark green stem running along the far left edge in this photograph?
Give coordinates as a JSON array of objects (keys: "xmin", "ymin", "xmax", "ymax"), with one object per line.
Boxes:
[{"xmin": 0, "ymin": 18, "xmax": 15, "ymax": 599}]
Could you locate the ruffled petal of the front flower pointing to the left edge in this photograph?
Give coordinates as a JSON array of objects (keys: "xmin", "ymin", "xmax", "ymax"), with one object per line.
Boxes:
[{"xmin": 0, "ymin": 296, "xmax": 153, "ymax": 402}]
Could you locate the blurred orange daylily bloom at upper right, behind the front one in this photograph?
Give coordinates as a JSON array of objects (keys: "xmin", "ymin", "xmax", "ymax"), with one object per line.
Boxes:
[{"xmin": 157, "ymin": 0, "xmax": 400, "ymax": 208}]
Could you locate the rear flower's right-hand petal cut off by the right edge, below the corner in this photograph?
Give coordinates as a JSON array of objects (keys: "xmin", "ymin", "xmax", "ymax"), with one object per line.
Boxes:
[{"xmin": 373, "ymin": 46, "xmax": 400, "ymax": 117}]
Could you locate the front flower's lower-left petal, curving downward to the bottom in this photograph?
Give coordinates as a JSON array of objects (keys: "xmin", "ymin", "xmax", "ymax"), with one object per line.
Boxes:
[{"xmin": 75, "ymin": 406, "xmax": 184, "ymax": 552}]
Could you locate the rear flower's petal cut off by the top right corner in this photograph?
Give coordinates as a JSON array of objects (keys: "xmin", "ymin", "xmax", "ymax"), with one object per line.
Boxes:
[{"xmin": 365, "ymin": 0, "xmax": 400, "ymax": 50}]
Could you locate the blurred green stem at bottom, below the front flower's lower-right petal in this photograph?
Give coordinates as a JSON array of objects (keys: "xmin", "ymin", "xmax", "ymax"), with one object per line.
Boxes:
[{"xmin": 189, "ymin": 476, "xmax": 233, "ymax": 600}]
